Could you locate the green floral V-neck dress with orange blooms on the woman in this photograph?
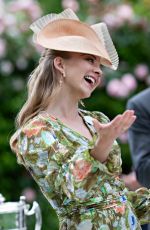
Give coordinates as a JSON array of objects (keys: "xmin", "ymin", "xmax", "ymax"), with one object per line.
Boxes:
[{"xmin": 17, "ymin": 110, "xmax": 150, "ymax": 230}]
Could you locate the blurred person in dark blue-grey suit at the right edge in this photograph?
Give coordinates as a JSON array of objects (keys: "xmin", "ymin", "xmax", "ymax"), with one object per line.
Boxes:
[{"xmin": 123, "ymin": 88, "xmax": 150, "ymax": 230}]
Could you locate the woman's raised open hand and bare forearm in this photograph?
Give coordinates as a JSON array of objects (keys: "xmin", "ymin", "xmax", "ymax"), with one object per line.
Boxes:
[{"xmin": 91, "ymin": 110, "xmax": 136, "ymax": 162}]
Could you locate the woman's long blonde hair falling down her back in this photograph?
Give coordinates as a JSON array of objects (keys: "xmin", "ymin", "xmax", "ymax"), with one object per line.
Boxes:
[{"xmin": 10, "ymin": 49, "xmax": 70, "ymax": 151}]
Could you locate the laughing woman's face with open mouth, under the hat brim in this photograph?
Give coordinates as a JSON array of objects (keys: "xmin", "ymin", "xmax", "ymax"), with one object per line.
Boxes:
[{"xmin": 63, "ymin": 53, "xmax": 102, "ymax": 99}]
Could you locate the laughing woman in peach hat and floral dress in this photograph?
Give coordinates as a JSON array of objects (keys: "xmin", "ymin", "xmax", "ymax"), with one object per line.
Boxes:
[{"xmin": 10, "ymin": 9, "xmax": 150, "ymax": 230}]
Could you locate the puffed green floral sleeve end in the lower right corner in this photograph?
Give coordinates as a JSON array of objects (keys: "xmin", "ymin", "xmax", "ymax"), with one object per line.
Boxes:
[{"xmin": 127, "ymin": 187, "xmax": 150, "ymax": 224}]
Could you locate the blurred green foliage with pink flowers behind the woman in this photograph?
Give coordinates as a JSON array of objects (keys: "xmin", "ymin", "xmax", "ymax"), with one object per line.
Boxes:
[{"xmin": 0, "ymin": 0, "xmax": 150, "ymax": 230}]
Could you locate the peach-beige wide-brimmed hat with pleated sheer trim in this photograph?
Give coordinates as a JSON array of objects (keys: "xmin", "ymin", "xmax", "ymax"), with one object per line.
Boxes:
[{"xmin": 30, "ymin": 9, "xmax": 119, "ymax": 70}]
